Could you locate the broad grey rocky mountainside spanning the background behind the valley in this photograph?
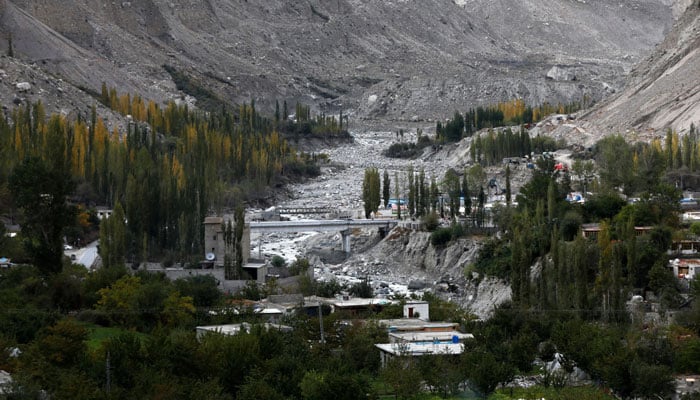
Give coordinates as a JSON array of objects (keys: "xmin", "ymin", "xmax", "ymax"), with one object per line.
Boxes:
[{"xmin": 0, "ymin": 0, "xmax": 687, "ymax": 120}]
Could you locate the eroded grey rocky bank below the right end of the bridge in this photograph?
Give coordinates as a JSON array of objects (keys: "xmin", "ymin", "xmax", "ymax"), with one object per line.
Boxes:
[{"xmin": 305, "ymin": 228, "xmax": 512, "ymax": 319}]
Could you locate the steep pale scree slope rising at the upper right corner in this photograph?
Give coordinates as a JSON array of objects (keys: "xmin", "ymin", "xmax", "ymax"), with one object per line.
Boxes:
[{"xmin": 585, "ymin": 1, "xmax": 700, "ymax": 138}]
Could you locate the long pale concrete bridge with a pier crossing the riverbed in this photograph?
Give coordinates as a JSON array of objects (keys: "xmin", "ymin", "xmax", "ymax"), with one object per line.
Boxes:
[{"xmin": 250, "ymin": 219, "xmax": 397, "ymax": 253}]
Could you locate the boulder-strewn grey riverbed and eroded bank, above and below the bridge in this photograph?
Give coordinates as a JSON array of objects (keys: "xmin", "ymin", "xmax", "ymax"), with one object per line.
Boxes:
[{"xmin": 252, "ymin": 126, "xmax": 526, "ymax": 317}]
